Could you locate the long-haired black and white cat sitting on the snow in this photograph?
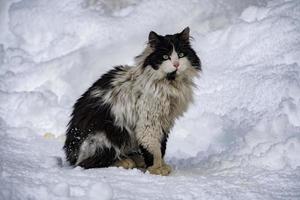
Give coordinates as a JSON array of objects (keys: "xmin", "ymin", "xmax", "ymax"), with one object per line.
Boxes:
[{"xmin": 64, "ymin": 27, "xmax": 201, "ymax": 175}]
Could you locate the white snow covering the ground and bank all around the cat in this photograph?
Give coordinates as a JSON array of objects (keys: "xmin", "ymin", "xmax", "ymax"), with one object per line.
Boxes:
[{"xmin": 0, "ymin": 0, "xmax": 300, "ymax": 200}]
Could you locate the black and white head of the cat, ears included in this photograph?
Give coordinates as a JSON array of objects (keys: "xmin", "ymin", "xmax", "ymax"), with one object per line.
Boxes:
[{"xmin": 144, "ymin": 27, "xmax": 201, "ymax": 80}]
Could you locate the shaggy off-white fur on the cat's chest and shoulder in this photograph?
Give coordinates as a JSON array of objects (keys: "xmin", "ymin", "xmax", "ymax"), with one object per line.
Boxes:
[{"xmin": 104, "ymin": 67, "xmax": 193, "ymax": 144}]
